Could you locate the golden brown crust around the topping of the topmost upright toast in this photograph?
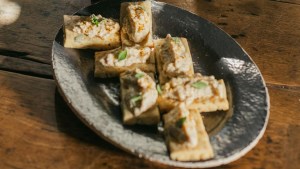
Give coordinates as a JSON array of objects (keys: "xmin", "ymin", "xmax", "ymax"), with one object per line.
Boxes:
[{"xmin": 120, "ymin": 1, "xmax": 153, "ymax": 47}]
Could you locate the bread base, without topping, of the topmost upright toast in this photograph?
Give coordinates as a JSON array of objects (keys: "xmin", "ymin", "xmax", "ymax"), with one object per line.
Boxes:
[{"xmin": 120, "ymin": 1, "xmax": 153, "ymax": 47}]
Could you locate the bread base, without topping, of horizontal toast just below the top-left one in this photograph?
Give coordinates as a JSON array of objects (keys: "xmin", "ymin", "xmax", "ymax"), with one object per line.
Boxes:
[{"xmin": 94, "ymin": 48, "xmax": 156, "ymax": 78}]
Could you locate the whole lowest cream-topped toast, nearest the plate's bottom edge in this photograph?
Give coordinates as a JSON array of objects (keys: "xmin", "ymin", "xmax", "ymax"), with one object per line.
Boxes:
[{"xmin": 163, "ymin": 104, "xmax": 214, "ymax": 161}]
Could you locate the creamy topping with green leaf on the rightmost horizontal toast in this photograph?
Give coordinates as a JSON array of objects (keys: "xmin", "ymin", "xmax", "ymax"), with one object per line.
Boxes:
[{"xmin": 162, "ymin": 74, "xmax": 225, "ymax": 105}]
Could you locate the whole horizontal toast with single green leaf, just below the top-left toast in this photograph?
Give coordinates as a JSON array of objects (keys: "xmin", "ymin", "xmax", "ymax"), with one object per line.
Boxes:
[{"xmin": 94, "ymin": 46, "xmax": 155, "ymax": 78}]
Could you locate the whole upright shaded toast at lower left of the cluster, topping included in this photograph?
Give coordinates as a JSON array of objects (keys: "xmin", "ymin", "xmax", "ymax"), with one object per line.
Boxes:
[{"xmin": 120, "ymin": 69, "xmax": 160, "ymax": 125}]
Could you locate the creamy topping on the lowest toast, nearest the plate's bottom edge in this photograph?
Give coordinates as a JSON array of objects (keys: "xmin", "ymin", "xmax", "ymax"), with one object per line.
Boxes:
[{"xmin": 165, "ymin": 103, "xmax": 198, "ymax": 147}]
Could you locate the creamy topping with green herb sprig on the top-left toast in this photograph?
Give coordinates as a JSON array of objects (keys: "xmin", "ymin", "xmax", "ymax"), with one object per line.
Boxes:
[{"xmin": 73, "ymin": 15, "xmax": 120, "ymax": 38}]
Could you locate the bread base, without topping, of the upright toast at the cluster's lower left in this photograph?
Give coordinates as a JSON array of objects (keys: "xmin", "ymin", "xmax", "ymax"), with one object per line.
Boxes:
[{"xmin": 120, "ymin": 72, "xmax": 160, "ymax": 125}]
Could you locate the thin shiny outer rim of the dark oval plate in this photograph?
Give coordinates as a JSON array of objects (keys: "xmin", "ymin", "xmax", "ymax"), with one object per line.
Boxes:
[{"xmin": 51, "ymin": 0, "xmax": 270, "ymax": 168}]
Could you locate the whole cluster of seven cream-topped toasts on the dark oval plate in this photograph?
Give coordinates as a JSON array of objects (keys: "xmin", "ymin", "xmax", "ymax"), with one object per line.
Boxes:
[{"xmin": 64, "ymin": 1, "xmax": 229, "ymax": 161}]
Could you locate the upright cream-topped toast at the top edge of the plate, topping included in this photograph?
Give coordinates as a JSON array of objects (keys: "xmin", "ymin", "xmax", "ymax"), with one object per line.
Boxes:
[{"xmin": 120, "ymin": 1, "xmax": 153, "ymax": 47}]
